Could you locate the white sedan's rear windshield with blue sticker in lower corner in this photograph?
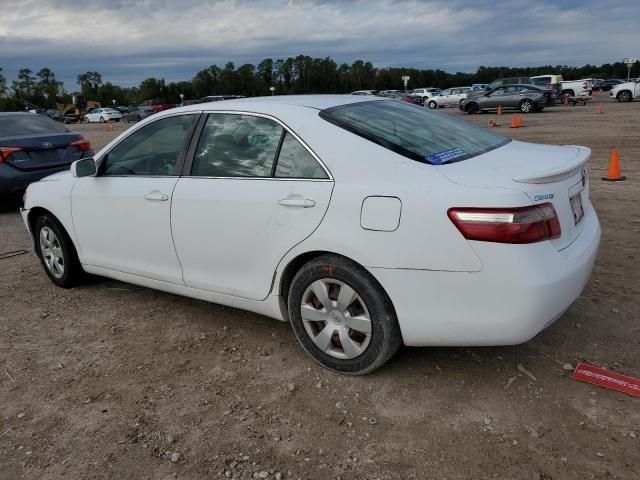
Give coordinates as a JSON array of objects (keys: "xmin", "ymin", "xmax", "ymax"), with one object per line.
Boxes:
[{"xmin": 320, "ymin": 100, "xmax": 510, "ymax": 165}]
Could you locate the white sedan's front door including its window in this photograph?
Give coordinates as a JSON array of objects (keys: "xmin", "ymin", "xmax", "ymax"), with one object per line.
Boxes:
[{"xmin": 71, "ymin": 114, "xmax": 198, "ymax": 283}]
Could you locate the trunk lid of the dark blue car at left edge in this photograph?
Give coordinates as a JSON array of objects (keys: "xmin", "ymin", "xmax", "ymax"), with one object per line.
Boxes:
[{"xmin": 0, "ymin": 132, "xmax": 84, "ymax": 171}]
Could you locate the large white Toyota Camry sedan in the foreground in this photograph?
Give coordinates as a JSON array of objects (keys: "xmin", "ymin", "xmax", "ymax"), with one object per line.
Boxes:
[{"xmin": 22, "ymin": 95, "xmax": 600, "ymax": 374}]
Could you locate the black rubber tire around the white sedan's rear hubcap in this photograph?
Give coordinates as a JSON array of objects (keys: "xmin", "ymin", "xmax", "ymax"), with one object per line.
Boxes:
[{"xmin": 288, "ymin": 255, "xmax": 402, "ymax": 375}]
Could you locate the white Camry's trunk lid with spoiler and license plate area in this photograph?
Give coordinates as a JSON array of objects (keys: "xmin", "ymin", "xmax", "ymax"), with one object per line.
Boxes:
[{"xmin": 438, "ymin": 140, "xmax": 591, "ymax": 250}]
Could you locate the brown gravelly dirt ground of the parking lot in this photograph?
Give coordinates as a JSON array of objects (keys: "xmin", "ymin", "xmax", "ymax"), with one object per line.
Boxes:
[{"xmin": 0, "ymin": 97, "xmax": 640, "ymax": 480}]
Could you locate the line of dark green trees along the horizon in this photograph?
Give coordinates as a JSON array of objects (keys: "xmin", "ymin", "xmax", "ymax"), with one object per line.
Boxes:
[{"xmin": 0, "ymin": 55, "xmax": 638, "ymax": 111}]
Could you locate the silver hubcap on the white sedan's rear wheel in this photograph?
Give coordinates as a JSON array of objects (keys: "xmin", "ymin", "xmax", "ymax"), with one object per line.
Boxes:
[{"xmin": 300, "ymin": 278, "xmax": 371, "ymax": 359}]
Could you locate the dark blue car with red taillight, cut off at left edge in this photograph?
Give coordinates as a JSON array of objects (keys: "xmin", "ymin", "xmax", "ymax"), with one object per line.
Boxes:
[{"xmin": 0, "ymin": 112, "xmax": 93, "ymax": 203}]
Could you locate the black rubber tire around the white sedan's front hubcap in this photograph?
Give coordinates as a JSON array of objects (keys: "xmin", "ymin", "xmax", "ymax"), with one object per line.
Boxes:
[{"xmin": 33, "ymin": 213, "xmax": 84, "ymax": 288}]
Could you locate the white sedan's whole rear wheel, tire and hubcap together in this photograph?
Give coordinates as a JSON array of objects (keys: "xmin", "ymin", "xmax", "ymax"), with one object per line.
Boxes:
[{"xmin": 288, "ymin": 255, "xmax": 402, "ymax": 375}]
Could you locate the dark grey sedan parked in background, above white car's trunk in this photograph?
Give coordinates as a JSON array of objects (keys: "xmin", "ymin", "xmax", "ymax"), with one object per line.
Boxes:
[{"xmin": 460, "ymin": 85, "xmax": 546, "ymax": 114}]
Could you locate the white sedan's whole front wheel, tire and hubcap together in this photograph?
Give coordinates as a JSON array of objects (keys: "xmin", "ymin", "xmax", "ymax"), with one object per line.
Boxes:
[{"xmin": 33, "ymin": 213, "xmax": 83, "ymax": 288}]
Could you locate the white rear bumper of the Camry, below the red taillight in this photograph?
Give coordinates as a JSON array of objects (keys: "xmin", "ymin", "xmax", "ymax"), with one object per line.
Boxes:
[{"xmin": 370, "ymin": 205, "xmax": 600, "ymax": 346}]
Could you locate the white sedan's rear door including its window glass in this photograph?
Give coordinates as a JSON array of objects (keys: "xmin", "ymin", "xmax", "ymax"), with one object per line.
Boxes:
[{"xmin": 171, "ymin": 112, "xmax": 333, "ymax": 300}]
